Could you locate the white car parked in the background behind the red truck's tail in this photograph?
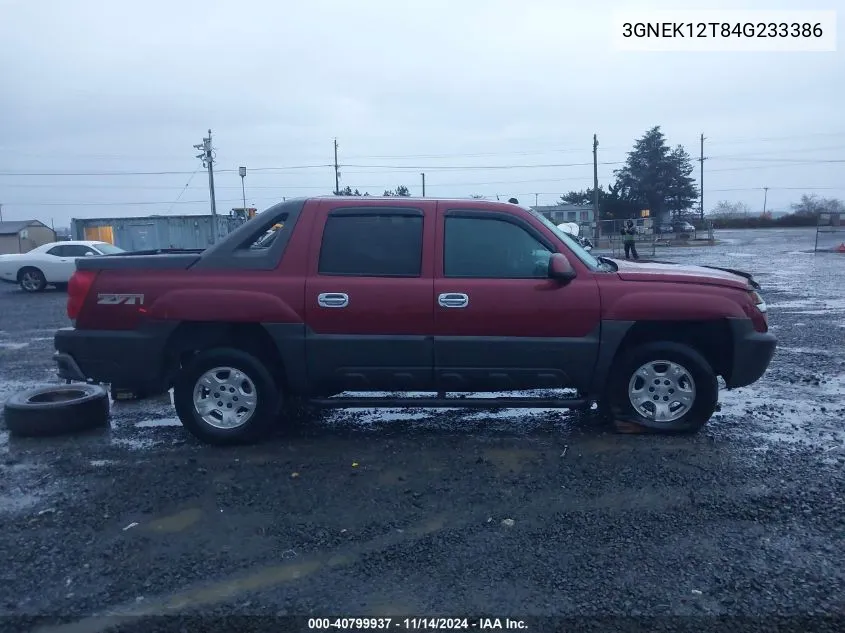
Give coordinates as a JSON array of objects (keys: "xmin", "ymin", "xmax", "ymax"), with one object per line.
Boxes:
[{"xmin": 0, "ymin": 241, "xmax": 126, "ymax": 292}]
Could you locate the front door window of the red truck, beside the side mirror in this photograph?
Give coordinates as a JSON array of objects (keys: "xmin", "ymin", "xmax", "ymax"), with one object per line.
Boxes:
[{"xmin": 443, "ymin": 217, "xmax": 552, "ymax": 279}]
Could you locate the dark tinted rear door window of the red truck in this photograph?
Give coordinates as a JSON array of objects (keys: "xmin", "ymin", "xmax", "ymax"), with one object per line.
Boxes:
[{"xmin": 318, "ymin": 212, "xmax": 423, "ymax": 277}]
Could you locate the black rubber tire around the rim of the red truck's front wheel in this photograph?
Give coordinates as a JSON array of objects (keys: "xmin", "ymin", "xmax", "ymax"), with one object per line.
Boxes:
[{"xmin": 607, "ymin": 341, "xmax": 719, "ymax": 433}]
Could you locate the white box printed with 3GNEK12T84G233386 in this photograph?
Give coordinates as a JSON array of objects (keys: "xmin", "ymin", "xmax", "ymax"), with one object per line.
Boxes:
[{"xmin": 613, "ymin": 10, "xmax": 836, "ymax": 52}]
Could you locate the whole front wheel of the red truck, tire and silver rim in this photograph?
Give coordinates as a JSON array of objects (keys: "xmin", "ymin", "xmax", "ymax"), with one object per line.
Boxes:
[{"xmin": 608, "ymin": 342, "xmax": 719, "ymax": 433}]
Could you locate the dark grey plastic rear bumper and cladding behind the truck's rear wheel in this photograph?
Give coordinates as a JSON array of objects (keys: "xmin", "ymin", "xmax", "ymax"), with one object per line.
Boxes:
[{"xmin": 53, "ymin": 325, "xmax": 173, "ymax": 388}]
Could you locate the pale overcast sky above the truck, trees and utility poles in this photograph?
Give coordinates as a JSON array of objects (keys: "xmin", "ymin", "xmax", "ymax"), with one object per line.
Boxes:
[{"xmin": 0, "ymin": 0, "xmax": 845, "ymax": 226}]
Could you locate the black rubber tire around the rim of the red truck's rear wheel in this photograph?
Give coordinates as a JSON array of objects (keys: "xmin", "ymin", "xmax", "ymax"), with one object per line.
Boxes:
[{"xmin": 173, "ymin": 348, "xmax": 281, "ymax": 446}]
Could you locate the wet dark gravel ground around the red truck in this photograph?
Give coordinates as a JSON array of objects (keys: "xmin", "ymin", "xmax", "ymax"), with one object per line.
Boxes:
[{"xmin": 0, "ymin": 229, "xmax": 845, "ymax": 631}]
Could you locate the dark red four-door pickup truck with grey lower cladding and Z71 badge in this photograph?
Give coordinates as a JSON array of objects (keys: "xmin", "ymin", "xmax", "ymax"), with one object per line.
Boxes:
[{"xmin": 55, "ymin": 196, "xmax": 777, "ymax": 444}]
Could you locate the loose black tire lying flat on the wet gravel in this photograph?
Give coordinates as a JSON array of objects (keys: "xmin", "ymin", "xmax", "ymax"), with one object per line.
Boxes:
[{"xmin": 3, "ymin": 383, "xmax": 109, "ymax": 437}]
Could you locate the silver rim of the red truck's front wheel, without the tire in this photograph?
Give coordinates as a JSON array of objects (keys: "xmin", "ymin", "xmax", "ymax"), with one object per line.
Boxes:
[{"xmin": 628, "ymin": 360, "xmax": 695, "ymax": 422}]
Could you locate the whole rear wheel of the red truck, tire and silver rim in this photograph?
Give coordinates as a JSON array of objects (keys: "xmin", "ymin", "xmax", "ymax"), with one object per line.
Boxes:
[{"xmin": 173, "ymin": 348, "xmax": 281, "ymax": 445}]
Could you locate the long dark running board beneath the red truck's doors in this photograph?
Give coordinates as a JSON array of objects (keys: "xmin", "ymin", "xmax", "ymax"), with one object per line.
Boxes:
[{"xmin": 309, "ymin": 398, "xmax": 590, "ymax": 409}]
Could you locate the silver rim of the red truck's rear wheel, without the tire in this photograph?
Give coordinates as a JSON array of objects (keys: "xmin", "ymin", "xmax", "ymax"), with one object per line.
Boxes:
[{"xmin": 194, "ymin": 367, "xmax": 258, "ymax": 429}]
